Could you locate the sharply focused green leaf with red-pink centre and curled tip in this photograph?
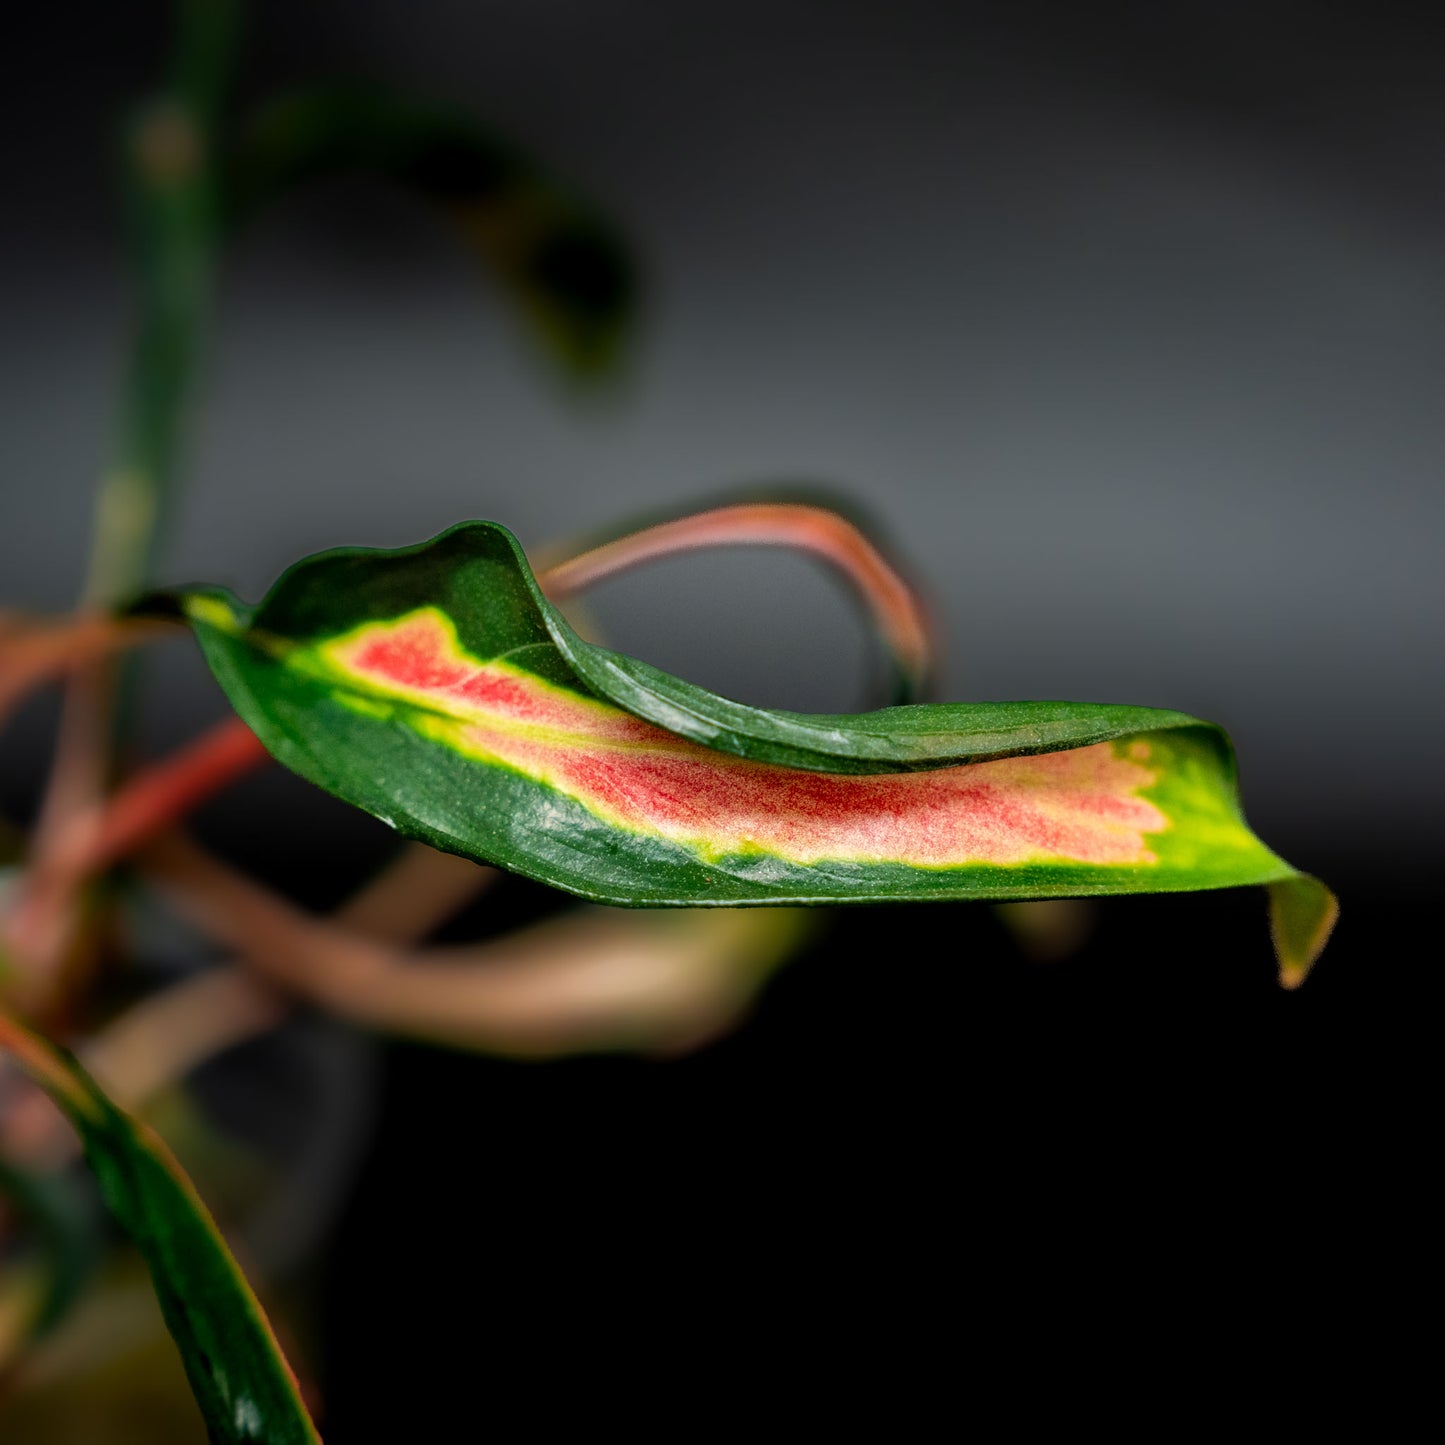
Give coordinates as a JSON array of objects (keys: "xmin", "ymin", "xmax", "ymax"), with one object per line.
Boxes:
[{"xmin": 166, "ymin": 522, "xmax": 1334, "ymax": 983}]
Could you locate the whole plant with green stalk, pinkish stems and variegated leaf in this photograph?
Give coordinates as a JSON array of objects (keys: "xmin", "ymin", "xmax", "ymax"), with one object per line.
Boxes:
[{"xmin": 0, "ymin": 0, "xmax": 1335, "ymax": 1445}]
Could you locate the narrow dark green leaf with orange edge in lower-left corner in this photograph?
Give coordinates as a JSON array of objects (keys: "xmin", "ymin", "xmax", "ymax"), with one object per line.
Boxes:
[{"xmin": 0, "ymin": 1014, "xmax": 319, "ymax": 1445}]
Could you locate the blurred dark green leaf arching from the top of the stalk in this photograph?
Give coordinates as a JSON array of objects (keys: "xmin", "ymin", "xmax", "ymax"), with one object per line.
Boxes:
[{"xmin": 230, "ymin": 84, "xmax": 636, "ymax": 373}]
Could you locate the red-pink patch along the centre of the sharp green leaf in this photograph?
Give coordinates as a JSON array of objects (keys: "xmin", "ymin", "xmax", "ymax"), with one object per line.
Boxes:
[{"xmin": 319, "ymin": 608, "xmax": 1169, "ymax": 868}]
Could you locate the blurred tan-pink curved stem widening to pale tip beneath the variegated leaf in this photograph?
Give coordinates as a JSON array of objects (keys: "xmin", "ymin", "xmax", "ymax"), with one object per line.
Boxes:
[{"xmin": 139, "ymin": 834, "xmax": 811, "ymax": 1056}]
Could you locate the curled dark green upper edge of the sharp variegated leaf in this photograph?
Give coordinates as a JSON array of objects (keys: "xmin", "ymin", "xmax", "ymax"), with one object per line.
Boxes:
[{"xmin": 186, "ymin": 522, "xmax": 1207, "ymax": 773}]
